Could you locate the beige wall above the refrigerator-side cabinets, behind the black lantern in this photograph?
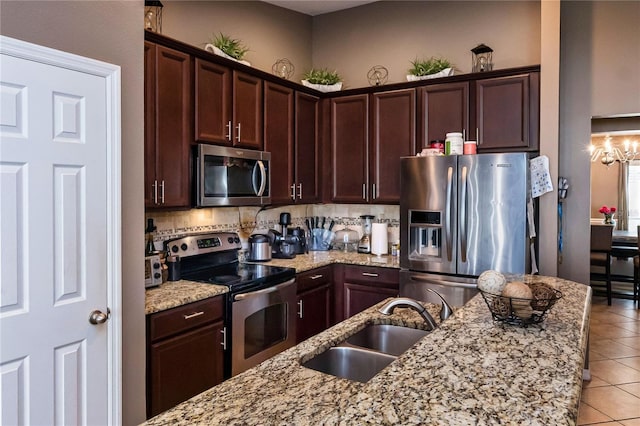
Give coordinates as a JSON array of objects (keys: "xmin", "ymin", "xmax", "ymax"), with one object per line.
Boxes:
[{"xmin": 313, "ymin": 1, "xmax": 540, "ymax": 88}]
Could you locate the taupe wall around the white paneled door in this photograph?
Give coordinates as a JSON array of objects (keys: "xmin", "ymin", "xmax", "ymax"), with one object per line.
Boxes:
[{"xmin": 0, "ymin": 0, "xmax": 145, "ymax": 424}]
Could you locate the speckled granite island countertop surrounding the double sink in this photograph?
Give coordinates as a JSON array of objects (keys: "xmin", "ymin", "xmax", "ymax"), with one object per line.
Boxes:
[{"xmin": 146, "ymin": 276, "xmax": 591, "ymax": 426}]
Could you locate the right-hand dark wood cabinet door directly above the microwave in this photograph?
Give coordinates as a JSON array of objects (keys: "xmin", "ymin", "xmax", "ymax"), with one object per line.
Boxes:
[{"xmin": 233, "ymin": 71, "xmax": 263, "ymax": 149}]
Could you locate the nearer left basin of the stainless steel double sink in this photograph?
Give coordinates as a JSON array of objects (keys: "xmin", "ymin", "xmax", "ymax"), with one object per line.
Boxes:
[{"xmin": 302, "ymin": 346, "xmax": 396, "ymax": 383}]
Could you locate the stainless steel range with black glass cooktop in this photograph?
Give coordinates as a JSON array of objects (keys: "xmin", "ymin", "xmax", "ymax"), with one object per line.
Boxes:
[{"xmin": 165, "ymin": 232, "xmax": 296, "ymax": 378}]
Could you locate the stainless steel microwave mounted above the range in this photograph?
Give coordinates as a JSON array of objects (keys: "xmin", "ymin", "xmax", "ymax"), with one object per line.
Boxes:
[{"xmin": 195, "ymin": 144, "xmax": 271, "ymax": 207}]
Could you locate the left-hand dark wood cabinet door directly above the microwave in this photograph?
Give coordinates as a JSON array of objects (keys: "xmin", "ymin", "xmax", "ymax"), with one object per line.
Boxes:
[{"xmin": 195, "ymin": 59, "xmax": 233, "ymax": 146}]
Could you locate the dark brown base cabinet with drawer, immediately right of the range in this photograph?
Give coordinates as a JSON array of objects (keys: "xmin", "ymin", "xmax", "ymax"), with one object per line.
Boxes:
[{"xmin": 296, "ymin": 266, "xmax": 333, "ymax": 343}]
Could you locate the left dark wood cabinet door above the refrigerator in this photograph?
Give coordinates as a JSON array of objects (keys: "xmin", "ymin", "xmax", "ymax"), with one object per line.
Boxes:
[{"xmin": 419, "ymin": 81, "xmax": 472, "ymax": 149}]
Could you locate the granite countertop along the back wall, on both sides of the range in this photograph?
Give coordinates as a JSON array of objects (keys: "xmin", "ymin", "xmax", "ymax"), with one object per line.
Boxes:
[{"xmin": 145, "ymin": 251, "xmax": 400, "ymax": 315}]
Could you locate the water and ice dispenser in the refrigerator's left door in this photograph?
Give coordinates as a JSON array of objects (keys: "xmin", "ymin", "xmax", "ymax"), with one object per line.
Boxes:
[{"xmin": 409, "ymin": 210, "xmax": 443, "ymax": 261}]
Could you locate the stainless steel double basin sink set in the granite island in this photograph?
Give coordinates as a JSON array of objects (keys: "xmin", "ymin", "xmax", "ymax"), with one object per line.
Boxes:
[{"xmin": 302, "ymin": 324, "xmax": 429, "ymax": 383}]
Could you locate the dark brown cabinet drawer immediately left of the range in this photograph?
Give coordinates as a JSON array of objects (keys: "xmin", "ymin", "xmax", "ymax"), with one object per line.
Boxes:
[{"xmin": 149, "ymin": 296, "xmax": 224, "ymax": 341}]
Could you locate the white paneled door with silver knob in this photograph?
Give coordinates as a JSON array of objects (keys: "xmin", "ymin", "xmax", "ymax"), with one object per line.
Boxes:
[{"xmin": 0, "ymin": 37, "xmax": 121, "ymax": 425}]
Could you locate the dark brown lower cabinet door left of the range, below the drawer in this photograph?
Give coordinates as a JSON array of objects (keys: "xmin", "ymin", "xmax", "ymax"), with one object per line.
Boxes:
[{"xmin": 147, "ymin": 322, "xmax": 223, "ymax": 418}]
